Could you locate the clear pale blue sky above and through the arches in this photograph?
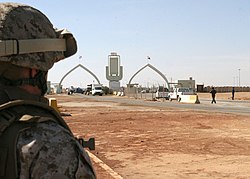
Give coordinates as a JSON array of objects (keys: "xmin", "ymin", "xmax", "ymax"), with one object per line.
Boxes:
[{"xmin": 3, "ymin": 0, "xmax": 250, "ymax": 87}]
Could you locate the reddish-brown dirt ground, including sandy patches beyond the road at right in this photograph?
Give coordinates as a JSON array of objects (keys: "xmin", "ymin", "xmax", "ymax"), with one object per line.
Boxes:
[{"xmin": 48, "ymin": 93, "xmax": 250, "ymax": 179}]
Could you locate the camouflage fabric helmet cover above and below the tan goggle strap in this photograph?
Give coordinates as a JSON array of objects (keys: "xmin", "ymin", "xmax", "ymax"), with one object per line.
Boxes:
[{"xmin": 0, "ymin": 3, "xmax": 65, "ymax": 71}]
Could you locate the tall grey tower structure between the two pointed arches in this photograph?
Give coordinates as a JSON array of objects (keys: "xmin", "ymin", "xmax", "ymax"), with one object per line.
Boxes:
[{"xmin": 106, "ymin": 52, "xmax": 123, "ymax": 91}]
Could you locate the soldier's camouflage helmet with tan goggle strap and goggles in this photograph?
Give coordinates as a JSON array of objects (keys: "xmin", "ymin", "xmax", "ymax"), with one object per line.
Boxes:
[{"xmin": 0, "ymin": 3, "xmax": 77, "ymax": 71}]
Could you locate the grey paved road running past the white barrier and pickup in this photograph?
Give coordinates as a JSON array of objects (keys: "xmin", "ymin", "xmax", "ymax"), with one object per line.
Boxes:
[{"xmin": 69, "ymin": 94, "xmax": 250, "ymax": 115}]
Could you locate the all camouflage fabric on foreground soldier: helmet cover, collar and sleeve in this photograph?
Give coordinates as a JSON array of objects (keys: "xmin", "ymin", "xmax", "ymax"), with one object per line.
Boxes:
[{"xmin": 0, "ymin": 3, "xmax": 95, "ymax": 179}]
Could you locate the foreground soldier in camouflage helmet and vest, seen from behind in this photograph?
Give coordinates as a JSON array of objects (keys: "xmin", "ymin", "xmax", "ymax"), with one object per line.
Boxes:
[{"xmin": 0, "ymin": 3, "xmax": 95, "ymax": 179}]
